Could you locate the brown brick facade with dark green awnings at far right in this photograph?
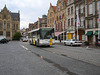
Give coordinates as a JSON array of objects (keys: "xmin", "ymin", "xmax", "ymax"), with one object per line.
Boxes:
[{"xmin": 85, "ymin": 0, "xmax": 100, "ymax": 44}]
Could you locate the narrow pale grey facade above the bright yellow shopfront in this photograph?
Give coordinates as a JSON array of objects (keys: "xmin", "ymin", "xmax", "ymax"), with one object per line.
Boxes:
[{"xmin": 66, "ymin": 0, "xmax": 75, "ymax": 39}]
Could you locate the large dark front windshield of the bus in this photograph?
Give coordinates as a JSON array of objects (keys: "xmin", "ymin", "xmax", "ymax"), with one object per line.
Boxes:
[{"xmin": 40, "ymin": 28, "xmax": 54, "ymax": 39}]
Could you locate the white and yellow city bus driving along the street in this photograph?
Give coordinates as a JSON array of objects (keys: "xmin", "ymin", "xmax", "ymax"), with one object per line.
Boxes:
[{"xmin": 28, "ymin": 28, "xmax": 55, "ymax": 46}]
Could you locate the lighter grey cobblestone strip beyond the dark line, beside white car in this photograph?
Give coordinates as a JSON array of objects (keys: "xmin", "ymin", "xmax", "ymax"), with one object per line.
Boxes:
[{"xmin": 43, "ymin": 43, "xmax": 100, "ymax": 66}]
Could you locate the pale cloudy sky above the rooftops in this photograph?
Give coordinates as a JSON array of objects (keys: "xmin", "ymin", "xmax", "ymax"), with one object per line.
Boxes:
[{"xmin": 0, "ymin": 0, "xmax": 57, "ymax": 29}]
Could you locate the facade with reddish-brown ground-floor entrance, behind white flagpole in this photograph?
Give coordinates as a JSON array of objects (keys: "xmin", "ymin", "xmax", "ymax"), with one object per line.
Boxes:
[{"xmin": 74, "ymin": 0, "xmax": 85, "ymax": 41}]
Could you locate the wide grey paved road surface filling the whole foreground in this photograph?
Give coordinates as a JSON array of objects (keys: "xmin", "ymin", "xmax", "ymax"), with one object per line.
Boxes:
[{"xmin": 0, "ymin": 41, "xmax": 100, "ymax": 75}]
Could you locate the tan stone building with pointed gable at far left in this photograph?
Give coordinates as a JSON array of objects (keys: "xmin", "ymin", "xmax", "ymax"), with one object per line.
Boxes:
[{"xmin": 0, "ymin": 5, "xmax": 20, "ymax": 40}]
